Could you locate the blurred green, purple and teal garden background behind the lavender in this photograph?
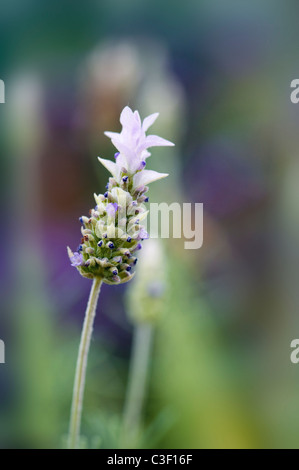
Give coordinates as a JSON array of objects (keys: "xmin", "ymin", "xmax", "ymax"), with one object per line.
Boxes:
[{"xmin": 0, "ymin": 0, "xmax": 299, "ymax": 449}]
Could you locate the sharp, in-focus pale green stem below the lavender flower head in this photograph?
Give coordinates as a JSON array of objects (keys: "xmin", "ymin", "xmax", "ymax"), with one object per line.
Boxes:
[{"xmin": 68, "ymin": 277, "xmax": 102, "ymax": 449}]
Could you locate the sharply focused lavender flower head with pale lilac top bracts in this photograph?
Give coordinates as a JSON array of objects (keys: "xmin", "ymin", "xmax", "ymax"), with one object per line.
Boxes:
[{"xmin": 68, "ymin": 106, "xmax": 174, "ymax": 284}]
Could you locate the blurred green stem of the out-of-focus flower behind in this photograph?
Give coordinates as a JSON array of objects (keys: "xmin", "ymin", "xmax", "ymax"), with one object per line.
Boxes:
[{"xmin": 122, "ymin": 323, "xmax": 153, "ymax": 447}]
